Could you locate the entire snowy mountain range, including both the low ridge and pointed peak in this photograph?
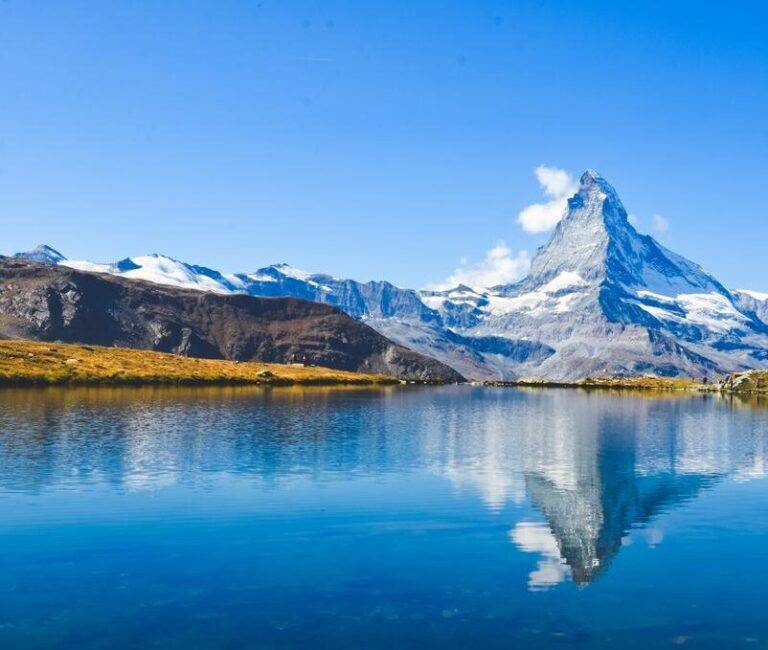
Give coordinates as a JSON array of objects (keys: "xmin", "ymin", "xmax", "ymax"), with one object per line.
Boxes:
[{"xmin": 16, "ymin": 171, "xmax": 768, "ymax": 381}]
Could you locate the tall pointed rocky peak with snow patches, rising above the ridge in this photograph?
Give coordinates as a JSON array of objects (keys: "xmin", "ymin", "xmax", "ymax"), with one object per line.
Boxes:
[{"xmin": 426, "ymin": 171, "xmax": 768, "ymax": 380}]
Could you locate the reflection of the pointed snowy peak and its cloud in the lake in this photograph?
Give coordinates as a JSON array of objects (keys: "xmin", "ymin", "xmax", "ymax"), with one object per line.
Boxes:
[{"xmin": 420, "ymin": 391, "xmax": 768, "ymax": 590}]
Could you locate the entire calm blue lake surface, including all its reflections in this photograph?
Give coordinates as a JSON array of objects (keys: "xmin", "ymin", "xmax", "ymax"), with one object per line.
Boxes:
[{"xmin": 0, "ymin": 387, "xmax": 768, "ymax": 648}]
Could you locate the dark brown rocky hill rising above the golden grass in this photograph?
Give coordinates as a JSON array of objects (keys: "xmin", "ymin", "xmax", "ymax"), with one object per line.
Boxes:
[{"xmin": 0, "ymin": 258, "xmax": 463, "ymax": 382}]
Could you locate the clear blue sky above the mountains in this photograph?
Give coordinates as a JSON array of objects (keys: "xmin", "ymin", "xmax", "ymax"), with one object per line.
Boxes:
[{"xmin": 0, "ymin": 0, "xmax": 768, "ymax": 290}]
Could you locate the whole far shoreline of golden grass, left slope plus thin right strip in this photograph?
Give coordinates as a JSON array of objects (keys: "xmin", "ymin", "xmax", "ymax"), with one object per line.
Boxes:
[{"xmin": 0, "ymin": 339, "xmax": 768, "ymax": 397}]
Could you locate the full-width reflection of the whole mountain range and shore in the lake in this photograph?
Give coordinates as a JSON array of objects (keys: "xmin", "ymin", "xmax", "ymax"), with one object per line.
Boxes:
[{"xmin": 0, "ymin": 387, "xmax": 768, "ymax": 589}]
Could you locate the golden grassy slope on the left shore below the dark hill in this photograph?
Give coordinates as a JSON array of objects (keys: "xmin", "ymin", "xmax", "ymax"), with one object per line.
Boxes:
[{"xmin": 0, "ymin": 341, "xmax": 399, "ymax": 385}]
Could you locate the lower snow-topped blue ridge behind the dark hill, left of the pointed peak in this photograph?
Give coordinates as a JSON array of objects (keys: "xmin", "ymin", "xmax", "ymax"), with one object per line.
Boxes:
[{"xmin": 9, "ymin": 245, "xmax": 554, "ymax": 379}]
